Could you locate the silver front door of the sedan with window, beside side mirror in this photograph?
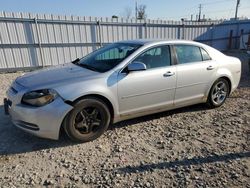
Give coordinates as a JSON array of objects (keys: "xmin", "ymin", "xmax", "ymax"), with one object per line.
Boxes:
[{"xmin": 118, "ymin": 45, "xmax": 176, "ymax": 115}]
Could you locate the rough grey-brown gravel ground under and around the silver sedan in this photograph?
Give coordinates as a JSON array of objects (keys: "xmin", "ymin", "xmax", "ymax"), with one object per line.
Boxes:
[{"xmin": 0, "ymin": 51, "xmax": 250, "ymax": 187}]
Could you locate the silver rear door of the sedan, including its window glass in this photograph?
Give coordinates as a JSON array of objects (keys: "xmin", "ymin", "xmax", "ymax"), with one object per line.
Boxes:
[{"xmin": 174, "ymin": 44, "xmax": 217, "ymax": 106}]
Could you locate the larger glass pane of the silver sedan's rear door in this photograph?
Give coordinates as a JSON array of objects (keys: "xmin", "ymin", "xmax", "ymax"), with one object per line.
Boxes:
[{"xmin": 175, "ymin": 45, "xmax": 202, "ymax": 64}]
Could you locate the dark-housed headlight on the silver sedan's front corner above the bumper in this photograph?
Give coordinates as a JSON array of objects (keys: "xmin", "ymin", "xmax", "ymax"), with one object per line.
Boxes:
[{"xmin": 22, "ymin": 89, "xmax": 58, "ymax": 107}]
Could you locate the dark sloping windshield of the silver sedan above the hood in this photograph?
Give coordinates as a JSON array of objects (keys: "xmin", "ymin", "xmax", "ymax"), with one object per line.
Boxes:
[{"xmin": 75, "ymin": 43, "xmax": 142, "ymax": 72}]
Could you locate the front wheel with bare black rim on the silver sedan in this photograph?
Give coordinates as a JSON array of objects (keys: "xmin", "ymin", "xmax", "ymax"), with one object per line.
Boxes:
[{"xmin": 63, "ymin": 98, "xmax": 110, "ymax": 142}]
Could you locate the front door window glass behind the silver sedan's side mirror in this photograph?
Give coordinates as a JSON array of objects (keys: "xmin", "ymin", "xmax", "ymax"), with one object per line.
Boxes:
[{"xmin": 134, "ymin": 45, "xmax": 171, "ymax": 69}]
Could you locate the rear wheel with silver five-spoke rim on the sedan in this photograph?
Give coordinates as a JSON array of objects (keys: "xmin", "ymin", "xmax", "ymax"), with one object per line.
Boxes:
[{"xmin": 207, "ymin": 78, "xmax": 230, "ymax": 108}]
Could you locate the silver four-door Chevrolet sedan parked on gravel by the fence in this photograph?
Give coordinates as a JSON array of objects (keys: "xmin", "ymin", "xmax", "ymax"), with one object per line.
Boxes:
[{"xmin": 4, "ymin": 40, "xmax": 241, "ymax": 142}]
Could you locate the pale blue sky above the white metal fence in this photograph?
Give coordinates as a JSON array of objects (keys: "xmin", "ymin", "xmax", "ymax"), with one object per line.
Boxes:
[{"xmin": 0, "ymin": 0, "xmax": 250, "ymax": 20}]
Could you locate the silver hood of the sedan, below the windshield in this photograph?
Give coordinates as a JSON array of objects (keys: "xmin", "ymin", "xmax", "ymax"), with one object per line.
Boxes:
[{"xmin": 16, "ymin": 63, "xmax": 100, "ymax": 88}]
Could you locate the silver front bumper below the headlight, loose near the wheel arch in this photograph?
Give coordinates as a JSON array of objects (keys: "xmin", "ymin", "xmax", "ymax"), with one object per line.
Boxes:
[{"xmin": 4, "ymin": 96, "xmax": 73, "ymax": 140}]
